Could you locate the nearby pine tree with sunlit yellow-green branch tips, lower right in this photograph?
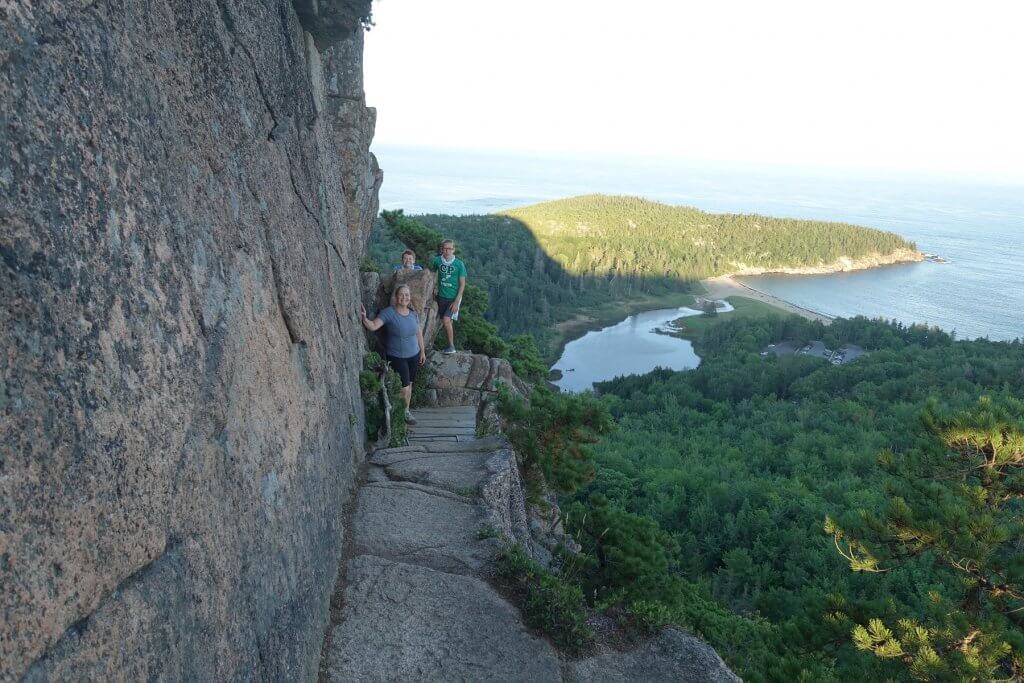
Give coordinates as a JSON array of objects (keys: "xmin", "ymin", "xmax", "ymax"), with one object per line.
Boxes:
[{"xmin": 825, "ymin": 395, "xmax": 1024, "ymax": 681}]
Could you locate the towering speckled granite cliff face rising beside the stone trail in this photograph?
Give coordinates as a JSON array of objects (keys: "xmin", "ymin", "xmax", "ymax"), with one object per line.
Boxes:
[{"xmin": 0, "ymin": 0, "xmax": 381, "ymax": 680}]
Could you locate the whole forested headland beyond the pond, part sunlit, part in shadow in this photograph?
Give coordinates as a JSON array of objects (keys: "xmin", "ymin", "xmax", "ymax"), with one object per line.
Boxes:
[{"xmin": 370, "ymin": 195, "xmax": 913, "ymax": 352}]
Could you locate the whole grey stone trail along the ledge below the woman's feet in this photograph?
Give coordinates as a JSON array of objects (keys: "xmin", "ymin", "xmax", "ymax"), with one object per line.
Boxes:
[{"xmin": 321, "ymin": 407, "xmax": 738, "ymax": 682}]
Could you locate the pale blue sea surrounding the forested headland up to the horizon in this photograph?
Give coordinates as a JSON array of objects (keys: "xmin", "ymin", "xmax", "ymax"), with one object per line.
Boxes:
[{"xmin": 374, "ymin": 147, "xmax": 1024, "ymax": 342}]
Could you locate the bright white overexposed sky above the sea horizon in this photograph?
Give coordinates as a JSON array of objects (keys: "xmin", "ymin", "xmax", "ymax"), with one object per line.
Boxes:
[{"xmin": 365, "ymin": 0, "xmax": 1024, "ymax": 182}]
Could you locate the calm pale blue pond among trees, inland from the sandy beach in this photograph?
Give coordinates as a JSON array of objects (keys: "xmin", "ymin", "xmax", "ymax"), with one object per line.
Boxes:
[{"xmin": 552, "ymin": 302, "xmax": 732, "ymax": 391}]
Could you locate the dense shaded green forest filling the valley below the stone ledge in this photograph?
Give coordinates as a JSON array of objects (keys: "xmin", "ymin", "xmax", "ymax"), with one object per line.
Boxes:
[{"xmin": 563, "ymin": 316, "xmax": 1024, "ymax": 681}]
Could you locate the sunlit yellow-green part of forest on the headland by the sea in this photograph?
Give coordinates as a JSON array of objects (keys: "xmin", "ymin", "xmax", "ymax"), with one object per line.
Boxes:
[{"xmin": 498, "ymin": 195, "xmax": 914, "ymax": 281}]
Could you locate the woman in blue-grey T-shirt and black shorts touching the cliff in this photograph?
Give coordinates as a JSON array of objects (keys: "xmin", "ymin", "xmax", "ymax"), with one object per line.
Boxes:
[{"xmin": 359, "ymin": 285, "xmax": 427, "ymax": 425}]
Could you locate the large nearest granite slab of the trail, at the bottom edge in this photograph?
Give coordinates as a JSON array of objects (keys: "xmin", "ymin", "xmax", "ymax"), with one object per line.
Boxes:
[{"xmin": 327, "ymin": 555, "xmax": 561, "ymax": 682}]
